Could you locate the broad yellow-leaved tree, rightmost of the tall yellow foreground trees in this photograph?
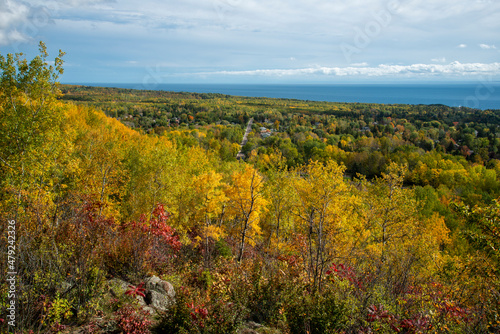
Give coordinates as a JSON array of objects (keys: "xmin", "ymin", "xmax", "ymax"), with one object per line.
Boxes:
[{"xmin": 360, "ymin": 163, "xmax": 448, "ymax": 293}]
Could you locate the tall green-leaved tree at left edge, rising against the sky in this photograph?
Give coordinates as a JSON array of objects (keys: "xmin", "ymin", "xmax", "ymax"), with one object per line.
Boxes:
[{"xmin": 0, "ymin": 42, "xmax": 64, "ymax": 217}]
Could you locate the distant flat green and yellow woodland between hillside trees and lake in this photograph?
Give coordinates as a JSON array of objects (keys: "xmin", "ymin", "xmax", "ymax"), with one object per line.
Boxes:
[{"xmin": 63, "ymin": 86, "xmax": 500, "ymax": 204}]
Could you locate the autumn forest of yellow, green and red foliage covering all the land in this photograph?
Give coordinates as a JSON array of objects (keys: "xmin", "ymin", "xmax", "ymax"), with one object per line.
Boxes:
[{"xmin": 0, "ymin": 43, "xmax": 500, "ymax": 334}]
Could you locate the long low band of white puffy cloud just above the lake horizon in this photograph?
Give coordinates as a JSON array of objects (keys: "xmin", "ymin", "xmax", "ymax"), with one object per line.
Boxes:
[{"xmin": 203, "ymin": 61, "xmax": 500, "ymax": 77}]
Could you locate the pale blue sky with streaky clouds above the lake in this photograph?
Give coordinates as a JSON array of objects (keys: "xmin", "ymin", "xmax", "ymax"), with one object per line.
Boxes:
[{"xmin": 0, "ymin": 0, "xmax": 500, "ymax": 86}]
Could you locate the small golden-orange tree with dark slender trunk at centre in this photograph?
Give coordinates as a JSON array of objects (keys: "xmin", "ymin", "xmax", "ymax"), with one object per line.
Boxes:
[{"xmin": 226, "ymin": 165, "xmax": 267, "ymax": 261}]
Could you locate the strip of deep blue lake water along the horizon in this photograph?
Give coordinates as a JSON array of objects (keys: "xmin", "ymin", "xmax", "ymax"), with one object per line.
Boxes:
[{"xmin": 77, "ymin": 82, "xmax": 500, "ymax": 110}]
